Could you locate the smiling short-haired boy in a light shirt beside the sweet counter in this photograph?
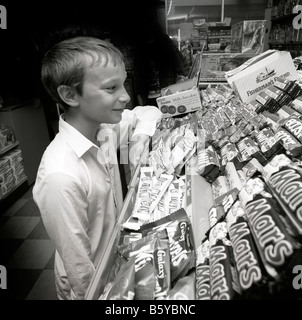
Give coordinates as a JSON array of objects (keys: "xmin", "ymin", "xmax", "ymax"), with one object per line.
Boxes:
[{"xmin": 33, "ymin": 37, "xmax": 161, "ymax": 300}]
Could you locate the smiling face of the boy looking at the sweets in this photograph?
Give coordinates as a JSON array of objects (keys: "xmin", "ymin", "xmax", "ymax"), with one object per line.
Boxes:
[{"xmin": 78, "ymin": 57, "xmax": 130, "ymax": 125}]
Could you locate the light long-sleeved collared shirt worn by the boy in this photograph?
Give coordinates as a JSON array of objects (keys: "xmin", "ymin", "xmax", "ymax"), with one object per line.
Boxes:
[{"xmin": 33, "ymin": 106, "xmax": 162, "ymax": 299}]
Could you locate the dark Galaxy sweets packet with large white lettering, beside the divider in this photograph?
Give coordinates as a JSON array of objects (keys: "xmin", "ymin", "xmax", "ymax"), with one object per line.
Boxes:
[{"xmin": 140, "ymin": 208, "xmax": 195, "ymax": 284}]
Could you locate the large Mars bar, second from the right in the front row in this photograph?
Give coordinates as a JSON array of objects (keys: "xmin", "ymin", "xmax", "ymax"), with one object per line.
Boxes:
[{"xmin": 239, "ymin": 177, "xmax": 301, "ymax": 281}]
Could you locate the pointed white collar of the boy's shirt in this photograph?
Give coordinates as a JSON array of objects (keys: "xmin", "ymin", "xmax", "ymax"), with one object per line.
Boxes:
[{"xmin": 59, "ymin": 114, "xmax": 97, "ymax": 158}]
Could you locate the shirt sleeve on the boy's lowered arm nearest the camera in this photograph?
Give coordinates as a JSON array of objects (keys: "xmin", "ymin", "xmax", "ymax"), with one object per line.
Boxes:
[{"xmin": 34, "ymin": 173, "xmax": 95, "ymax": 300}]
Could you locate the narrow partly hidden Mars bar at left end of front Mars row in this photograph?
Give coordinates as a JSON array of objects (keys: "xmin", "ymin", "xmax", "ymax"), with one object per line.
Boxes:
[{"xmin": 195, "ymin": 239, "xmax": 211, "ymax": 300}]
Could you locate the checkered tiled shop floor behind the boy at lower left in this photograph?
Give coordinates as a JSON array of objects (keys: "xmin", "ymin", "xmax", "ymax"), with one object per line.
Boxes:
[{"xmin": 0, "ymin": 187, "xmax": 57, "ymax": 300}]
